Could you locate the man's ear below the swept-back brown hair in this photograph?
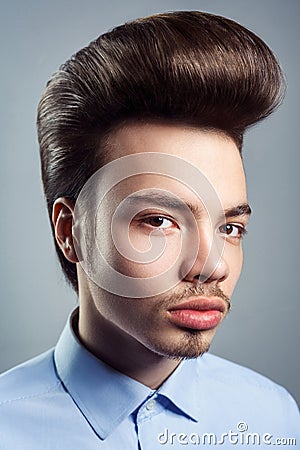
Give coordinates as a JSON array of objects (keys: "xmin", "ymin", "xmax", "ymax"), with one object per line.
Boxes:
[{"xmin": 52, "ymin": 197, "xmax": 79, "ymax": 263}]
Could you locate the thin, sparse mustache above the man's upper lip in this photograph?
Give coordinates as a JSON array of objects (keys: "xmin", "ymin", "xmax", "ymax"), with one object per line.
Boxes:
[{"xmin": 158, "ymin": 284, "xmax": 231, "ymax": 312}]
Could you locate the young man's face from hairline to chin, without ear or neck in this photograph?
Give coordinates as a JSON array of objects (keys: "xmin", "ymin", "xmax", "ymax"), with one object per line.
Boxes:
[{"xmin": 79, "ymin": 123, "xmax": 248, "ymax": 358}]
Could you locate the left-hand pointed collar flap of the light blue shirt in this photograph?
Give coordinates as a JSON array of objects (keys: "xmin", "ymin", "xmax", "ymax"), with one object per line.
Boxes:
[{"xmin": 54, "ymin": 310, "xmax": 153, "ymax": 439}]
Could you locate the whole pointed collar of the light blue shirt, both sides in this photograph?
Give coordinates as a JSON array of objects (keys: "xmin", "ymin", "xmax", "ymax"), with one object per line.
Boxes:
[{"xmin": 54, "ymin": 309, "xmax": 203, "ymax": 439}]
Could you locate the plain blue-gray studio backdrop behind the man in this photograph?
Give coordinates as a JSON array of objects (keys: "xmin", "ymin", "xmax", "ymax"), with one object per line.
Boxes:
[{"xmin": 0, "ymin": 0, "xmax": 300, "ymax": 402}]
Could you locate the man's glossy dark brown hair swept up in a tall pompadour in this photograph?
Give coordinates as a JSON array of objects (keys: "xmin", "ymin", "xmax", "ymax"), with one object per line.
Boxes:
[{"xmin": 37, "ymin": 11, "xmax": 285, "ymax": 291}]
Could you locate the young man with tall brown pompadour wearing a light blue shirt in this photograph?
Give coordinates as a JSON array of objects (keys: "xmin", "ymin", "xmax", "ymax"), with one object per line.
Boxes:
[{"xmin": 0, "ymin": 12, "xmax": 300, "ymax": 450}]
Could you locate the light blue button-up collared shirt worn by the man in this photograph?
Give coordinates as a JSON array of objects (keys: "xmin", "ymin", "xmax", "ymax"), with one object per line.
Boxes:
[{"xmin": 0, "ymin": 310, "xmax": 300, "ymax": 450}]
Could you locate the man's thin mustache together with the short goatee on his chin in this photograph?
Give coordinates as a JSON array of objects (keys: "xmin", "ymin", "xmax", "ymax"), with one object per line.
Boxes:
[{"xmin": 142, "ymin": 284, "xmax": 231, "ymax": 359}]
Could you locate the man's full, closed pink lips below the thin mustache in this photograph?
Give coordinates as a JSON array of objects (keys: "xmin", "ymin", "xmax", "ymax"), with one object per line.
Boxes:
[{"xmin": 168, "ymin": 297, "xmax": 227, "ymax": 330}]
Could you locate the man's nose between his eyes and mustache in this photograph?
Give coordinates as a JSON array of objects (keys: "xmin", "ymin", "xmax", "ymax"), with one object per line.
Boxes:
[{"xmin": 181, "ymin": 226, "xmax": 229, "ymax": 284}]
